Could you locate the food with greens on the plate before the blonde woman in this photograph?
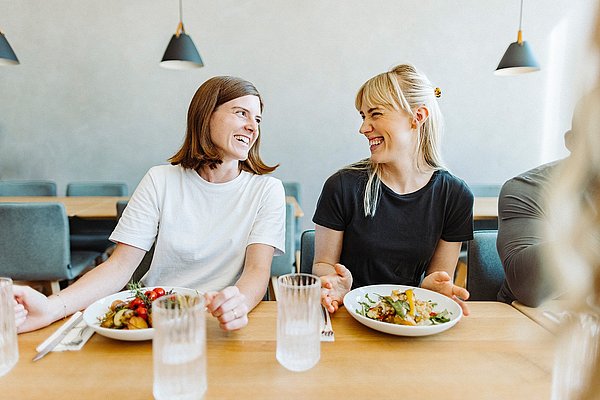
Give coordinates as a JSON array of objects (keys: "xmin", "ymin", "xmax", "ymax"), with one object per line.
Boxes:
[{"xmin": 356, "ymin": 289, "xmax": 451, "ymax": 326}]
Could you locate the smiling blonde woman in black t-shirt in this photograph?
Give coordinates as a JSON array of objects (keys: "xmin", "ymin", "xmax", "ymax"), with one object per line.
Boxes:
[{"xmin": 313, "ymin": 65, "xmax": 473, "ymax": 314}]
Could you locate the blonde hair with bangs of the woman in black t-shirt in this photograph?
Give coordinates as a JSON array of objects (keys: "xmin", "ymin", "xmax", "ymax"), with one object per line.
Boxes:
[{"xmin": 346, "ymin": 64, "xmax": 444, "ymax": 217}]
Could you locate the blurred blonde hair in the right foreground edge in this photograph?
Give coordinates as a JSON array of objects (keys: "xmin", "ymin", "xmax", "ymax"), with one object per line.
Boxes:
[{"xmin": 548, "ymin": 89, "xmax": 600, "ymax": 399}]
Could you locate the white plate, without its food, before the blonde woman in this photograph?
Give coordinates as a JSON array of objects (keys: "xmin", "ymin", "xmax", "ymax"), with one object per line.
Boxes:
[{"xmin": 344, "ymin": 285, "xmax": 462, "ymax": 336}]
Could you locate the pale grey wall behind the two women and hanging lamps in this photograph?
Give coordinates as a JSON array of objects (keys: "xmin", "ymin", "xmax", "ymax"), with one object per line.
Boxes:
[{"xmin": 0, "ymin": 0, "xmax": 595, "ymax": 227}]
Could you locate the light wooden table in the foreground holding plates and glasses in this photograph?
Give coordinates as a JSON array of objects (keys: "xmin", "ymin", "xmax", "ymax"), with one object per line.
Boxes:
[{"xmin": 0, "ymin": 302, "xmax": 553, "ymax": 400}]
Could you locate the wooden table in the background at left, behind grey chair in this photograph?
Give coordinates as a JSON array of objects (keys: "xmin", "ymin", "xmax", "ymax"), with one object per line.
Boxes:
[{"xmin": 0, "ymin": 196, "xmax": 129, "ymax": 219}]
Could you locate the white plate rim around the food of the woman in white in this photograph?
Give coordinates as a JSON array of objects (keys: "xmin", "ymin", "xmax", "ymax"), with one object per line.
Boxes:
[{"xmin": 83, "ymin": 286, "xmax": 198, "ymax": 341}]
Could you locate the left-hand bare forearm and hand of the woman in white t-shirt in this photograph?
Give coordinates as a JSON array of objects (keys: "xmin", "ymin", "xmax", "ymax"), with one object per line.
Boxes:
[{"xmin": 14, "ymin": 243, "xmax": 145, "ymax": 333}]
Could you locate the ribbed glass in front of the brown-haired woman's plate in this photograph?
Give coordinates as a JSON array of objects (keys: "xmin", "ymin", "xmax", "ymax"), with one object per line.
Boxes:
[{"xmin": 152, "ymin": 294, "xmax": 207, "ymax": 400}]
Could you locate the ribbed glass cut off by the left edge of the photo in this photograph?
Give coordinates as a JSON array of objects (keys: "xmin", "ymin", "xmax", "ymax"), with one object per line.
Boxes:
[{"xmin": 0, "ymin": 278, "xmax": 19, "ymax": 376}]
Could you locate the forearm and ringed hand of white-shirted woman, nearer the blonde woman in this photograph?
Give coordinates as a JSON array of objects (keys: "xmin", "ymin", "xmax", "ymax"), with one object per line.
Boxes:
[{"xmin": 206, "ymin": 243, "xmax": 275, "ymax": 331}]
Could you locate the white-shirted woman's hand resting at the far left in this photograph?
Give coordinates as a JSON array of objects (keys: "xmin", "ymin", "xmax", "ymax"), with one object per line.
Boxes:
[{"xmin": 13, "ymin": 285, "xmax": 54, "ymax": 333}]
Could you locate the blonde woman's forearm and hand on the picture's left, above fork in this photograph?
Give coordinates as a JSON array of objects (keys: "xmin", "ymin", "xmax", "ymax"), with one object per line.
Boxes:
[{"xmin": 313, "ymin": 225, "xmax": 352, "ymax": 313}]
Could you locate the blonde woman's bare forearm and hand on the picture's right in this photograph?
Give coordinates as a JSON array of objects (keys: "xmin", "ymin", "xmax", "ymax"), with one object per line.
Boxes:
[{"xmin": 421, "ymin": 239, "xmax": 469, "ymax": 315}]
